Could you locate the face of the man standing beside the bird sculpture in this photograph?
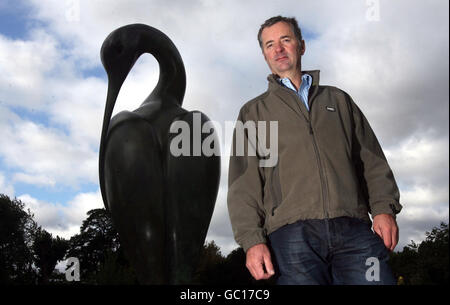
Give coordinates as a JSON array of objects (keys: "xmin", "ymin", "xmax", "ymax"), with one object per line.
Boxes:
[{"xmin": 261, "ymin": 22, "xmax": 305, "ymax": 77}]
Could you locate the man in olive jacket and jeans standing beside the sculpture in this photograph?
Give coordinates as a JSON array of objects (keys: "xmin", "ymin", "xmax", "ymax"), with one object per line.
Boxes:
[{"xmin": 227, "ymin": 16, "xmax": 402, "ymax": 284}]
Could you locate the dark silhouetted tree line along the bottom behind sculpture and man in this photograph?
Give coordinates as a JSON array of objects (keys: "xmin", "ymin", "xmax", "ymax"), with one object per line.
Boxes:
[{"xmin": 0, "ymin": 194, "xmax": 449, "ymax": 285}]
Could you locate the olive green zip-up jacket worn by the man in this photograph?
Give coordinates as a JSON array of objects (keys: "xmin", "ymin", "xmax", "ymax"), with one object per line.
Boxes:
[{"xmin": 227, "ymin": 71, "xmax": 402, "ymax": 251}]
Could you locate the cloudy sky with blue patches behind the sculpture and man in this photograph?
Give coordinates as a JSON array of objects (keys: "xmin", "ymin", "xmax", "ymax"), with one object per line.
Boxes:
[{"xmin": 0, "ymin": 0, "xmax": 449, "ymax": 254}]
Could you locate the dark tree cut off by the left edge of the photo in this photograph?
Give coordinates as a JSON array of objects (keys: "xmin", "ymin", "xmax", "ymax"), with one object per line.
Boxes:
[{"xmin": 0, "ymin": 194, "xmax": 37, "ymax": 284}]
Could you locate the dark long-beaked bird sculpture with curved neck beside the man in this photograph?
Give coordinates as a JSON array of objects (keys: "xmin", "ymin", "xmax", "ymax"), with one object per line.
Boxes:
[{"xmin": 99, "ymin": 24, "xmax": 220, "ymax": 284}]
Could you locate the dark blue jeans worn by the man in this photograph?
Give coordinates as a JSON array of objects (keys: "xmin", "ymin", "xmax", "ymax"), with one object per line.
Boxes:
[{"xmin": 269, "ymin": 217, "xmax": 396, "ymax": 285}]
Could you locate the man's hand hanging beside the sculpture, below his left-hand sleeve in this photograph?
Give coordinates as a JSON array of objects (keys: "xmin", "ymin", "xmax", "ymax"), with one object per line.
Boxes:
[{"xmin": 245, "ymin": 244, "xmax": 275, "ymax": 280}]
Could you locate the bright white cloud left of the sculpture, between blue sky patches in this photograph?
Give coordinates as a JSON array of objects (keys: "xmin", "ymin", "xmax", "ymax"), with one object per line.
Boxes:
[{"xmin": 0, "ymin": 116, "xmax": 98, "ymax": 187}]
